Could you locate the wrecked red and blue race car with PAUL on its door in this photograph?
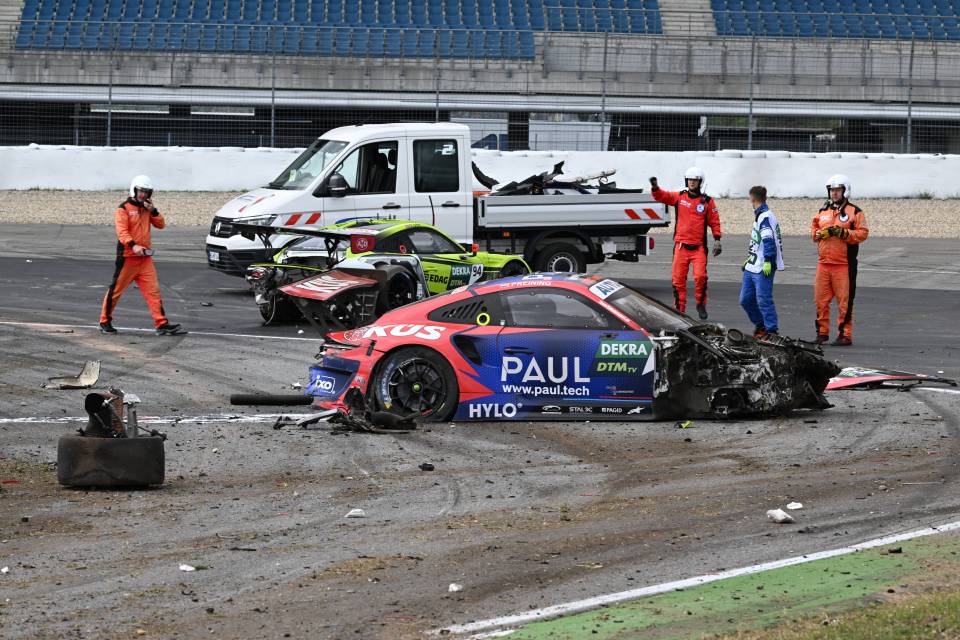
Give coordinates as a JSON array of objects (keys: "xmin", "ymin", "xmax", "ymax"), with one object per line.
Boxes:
[{"xmin": 307, "ymin": 274, "xmax": 839, "ymax": 420}]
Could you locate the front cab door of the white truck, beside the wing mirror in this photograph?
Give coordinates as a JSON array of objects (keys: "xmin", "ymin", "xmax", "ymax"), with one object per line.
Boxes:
[{"xmin": 325, "ymin": 139, "xmax": 409, "ymax": 222}]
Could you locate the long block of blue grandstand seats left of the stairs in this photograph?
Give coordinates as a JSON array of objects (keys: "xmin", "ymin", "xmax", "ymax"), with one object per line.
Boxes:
[{"xmin": 16, "ymin": 0, "xmax": 662, "ymax": 58}]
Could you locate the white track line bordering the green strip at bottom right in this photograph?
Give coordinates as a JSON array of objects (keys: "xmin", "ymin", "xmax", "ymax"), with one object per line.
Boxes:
[{"xmin": 431, "ymin": 521, "xmax": 960, "ymax": 638}]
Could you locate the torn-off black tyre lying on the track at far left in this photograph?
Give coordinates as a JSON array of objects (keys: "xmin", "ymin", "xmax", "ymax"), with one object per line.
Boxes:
[{"xmin": 57, "ymin": 436, "xmax": 164, "ymax": 487}]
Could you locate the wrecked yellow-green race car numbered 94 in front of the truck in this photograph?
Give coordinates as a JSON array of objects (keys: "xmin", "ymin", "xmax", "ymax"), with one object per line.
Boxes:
[{"xmin": 235, "ymin": 219, "xmax": 530, "ymax": 333}]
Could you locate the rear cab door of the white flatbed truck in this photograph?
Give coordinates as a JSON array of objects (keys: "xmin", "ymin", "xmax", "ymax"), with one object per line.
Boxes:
[{"xmin": 409, "ymin": 138, "xmax": 472, "ymax": 242}]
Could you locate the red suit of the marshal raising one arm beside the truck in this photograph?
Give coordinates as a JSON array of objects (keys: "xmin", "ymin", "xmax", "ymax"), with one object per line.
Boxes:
[{"xmin": 650, "ymin": 188, "xmax": 722, "ymax": 313}]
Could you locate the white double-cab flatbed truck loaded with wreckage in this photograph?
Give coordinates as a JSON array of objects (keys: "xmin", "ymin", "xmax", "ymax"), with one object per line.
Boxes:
[{"xmin": 206, "ymin": 123, "xmax": 670, "ymax": 276}]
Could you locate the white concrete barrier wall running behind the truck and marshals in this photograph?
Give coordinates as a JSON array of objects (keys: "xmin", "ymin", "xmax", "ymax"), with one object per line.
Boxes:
[{"xmin": 0, "ymin": 145, "xmax": 960, "ymax": 198}]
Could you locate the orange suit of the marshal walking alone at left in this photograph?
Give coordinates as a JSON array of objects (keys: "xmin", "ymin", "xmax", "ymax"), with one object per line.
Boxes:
[{"xmin": 100, "ymin": 198, "xmax": 167, "ymax": 327}]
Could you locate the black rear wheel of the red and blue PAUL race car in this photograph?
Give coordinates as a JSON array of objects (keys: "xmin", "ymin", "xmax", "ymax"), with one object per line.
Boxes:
[{"xmin": 373, "ymin": 347, "xmax": 460, "ymax": 420}]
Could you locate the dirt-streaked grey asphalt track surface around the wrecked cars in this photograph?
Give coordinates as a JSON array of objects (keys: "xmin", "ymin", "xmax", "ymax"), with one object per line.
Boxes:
[{"xmin": 0, "ymin": 225, "xmax": 960, "ymax": 638}]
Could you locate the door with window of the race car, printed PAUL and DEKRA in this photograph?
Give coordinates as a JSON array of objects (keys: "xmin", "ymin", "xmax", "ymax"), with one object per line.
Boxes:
[{"xmin": 498, "ymin": 286, "xmax": 654, "ymax": 419}]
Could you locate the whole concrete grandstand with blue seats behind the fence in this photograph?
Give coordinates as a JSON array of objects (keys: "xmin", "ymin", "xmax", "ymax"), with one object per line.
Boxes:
[{"xmin": 0, "ymin": 0, "xmax": 960, "ymax": 152}]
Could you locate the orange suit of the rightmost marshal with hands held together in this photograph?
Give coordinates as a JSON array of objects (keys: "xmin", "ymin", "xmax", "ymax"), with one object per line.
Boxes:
[{"xmin": 810, "ymin": 200, "xmax": 870, "ymax": 340}]
